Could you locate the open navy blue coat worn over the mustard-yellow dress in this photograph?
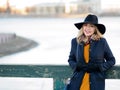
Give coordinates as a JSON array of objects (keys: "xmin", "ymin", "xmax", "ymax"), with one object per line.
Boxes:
[{"xmin": 67, "ymin": 38, "xmax": 115, "ymax": 90}]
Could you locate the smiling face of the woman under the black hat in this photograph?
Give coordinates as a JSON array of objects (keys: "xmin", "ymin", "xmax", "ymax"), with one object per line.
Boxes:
[{"xmin": 83, "ymin": 23, "xmax": 95, "ymax": 37}]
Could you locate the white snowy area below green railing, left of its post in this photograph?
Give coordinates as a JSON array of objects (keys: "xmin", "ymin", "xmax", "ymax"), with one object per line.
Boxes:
[{"xmin": 0, "ymin": 77, "xmax": 53, "ymax": 90}]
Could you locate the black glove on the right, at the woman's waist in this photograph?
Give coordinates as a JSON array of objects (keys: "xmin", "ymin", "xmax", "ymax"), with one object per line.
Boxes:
[{"xmin": 86, "ymin": 63, "xmax": 100, "ymax": 73}]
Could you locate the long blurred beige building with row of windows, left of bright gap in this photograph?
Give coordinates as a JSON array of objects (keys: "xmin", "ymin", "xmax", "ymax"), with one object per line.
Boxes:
[{"xmin": 29, "ymin": 3, "xmax": 65, "ymax": 16}]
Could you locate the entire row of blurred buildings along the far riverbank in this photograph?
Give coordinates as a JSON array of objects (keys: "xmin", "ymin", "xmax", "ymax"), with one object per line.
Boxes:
[{"xmin": 0, "ymin": 0, "xmax": 120, "ymax": 16}]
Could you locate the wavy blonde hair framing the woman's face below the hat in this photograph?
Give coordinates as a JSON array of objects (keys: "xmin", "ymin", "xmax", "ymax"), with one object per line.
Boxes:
[{"xmin": 77, "ymin": 25, "xmax": 103, "ymax": 43}]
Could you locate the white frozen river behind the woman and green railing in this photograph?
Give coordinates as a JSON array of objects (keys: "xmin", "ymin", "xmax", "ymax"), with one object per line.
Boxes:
[{"xmin": 0, "ymin": 17, "xmax": 120, "ymax": 90}]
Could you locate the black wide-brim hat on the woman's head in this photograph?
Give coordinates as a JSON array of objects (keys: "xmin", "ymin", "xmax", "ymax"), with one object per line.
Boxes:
[{"xmin": 74, "ymin": 14, "xmax": 106, "ymax": 34}]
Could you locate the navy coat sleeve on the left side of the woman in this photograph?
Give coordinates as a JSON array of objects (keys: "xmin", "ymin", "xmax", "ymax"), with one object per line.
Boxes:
[{"xmin": 68, "ymin": 38, "xmax": 77, "ymax": 70}]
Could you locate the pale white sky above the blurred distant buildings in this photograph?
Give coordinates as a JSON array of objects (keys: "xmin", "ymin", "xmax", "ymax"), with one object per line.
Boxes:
[{"xmin": 0, "ymin": 0, "xmax": 120, "ymax": 8}]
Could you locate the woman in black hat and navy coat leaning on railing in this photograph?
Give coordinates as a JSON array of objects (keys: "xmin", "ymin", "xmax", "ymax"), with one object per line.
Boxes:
[{"xmin": 67, "ymin": 14, "xmax": 115, "ymax": 90}]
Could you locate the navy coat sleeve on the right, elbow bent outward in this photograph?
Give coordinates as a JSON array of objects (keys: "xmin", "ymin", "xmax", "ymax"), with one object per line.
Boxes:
[{"xmin": 101, "ymin": 39, "xmax": 115, "ymax": 71}]
